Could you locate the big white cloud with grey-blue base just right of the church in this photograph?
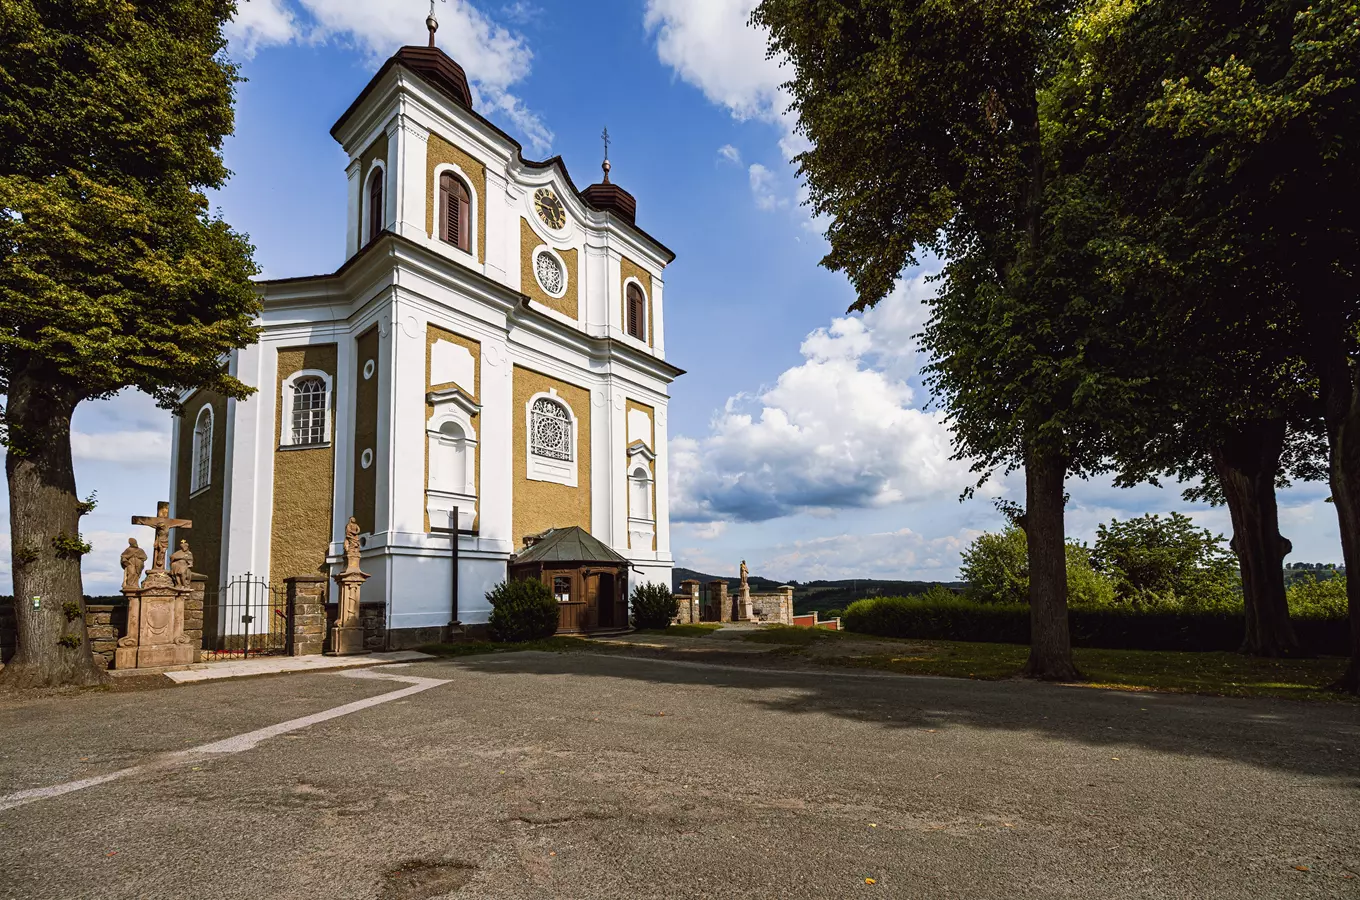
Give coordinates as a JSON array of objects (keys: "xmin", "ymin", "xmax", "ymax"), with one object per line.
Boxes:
[{"xmin": 670, "ymin": 265, "xmax": 972, "ymax": 523}]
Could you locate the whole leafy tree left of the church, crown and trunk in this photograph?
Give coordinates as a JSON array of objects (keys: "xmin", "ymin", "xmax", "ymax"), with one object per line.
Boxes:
[{"xmin": 0, "ymin": 0, "xmax": 258, "ymax": 685}]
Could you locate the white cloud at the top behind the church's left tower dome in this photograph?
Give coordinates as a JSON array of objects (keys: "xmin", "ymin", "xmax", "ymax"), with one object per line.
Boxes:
[{"xmin": 227, "ymin": 0, "xmax": 554, "ymax": 154}]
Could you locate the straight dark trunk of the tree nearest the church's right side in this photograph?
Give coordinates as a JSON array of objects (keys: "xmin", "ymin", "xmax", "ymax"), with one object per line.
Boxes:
[{"xmin": 1024, "ymin": 447, "xmax": 1080, "ymax": 681}]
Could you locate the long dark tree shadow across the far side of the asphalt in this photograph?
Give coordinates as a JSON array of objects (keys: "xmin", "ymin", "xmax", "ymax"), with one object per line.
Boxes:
[{"xmin": 446, "ymin": 653, "xmax": 1360, "ymax": 787}]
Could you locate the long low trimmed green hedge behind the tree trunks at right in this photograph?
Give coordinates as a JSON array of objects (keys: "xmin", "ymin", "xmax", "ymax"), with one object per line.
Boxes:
[{"xmin": 840, "ymin": 595, "xmax": 1350, "ymax": 655}]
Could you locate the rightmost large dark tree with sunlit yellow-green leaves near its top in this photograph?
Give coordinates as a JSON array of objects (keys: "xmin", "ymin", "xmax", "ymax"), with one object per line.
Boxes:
[{"xmin": 1066, "ymin": 0, "xmax": 1360, "ymax": 677}]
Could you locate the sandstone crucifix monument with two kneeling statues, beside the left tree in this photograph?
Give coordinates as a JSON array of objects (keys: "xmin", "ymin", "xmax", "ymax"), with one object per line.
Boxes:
[{"xmin": 113, "ymin": 502, "xmax": 194, "ymax": 669}]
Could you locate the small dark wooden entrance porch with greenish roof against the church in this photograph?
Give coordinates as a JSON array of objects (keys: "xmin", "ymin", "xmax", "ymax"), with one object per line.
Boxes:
[{"xmin": 509, "ymin": 526, "xmax": 628, "ymax": 634}]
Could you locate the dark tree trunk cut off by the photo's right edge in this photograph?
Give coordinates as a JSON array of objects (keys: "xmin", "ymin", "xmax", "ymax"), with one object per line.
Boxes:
[{"xmin": 1322, "ymin": 366, "xmax": 1360, "ymax": 693}]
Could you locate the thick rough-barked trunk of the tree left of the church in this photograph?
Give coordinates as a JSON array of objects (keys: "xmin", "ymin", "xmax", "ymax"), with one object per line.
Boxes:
[{"xmin": 0, "ymin": 368, "xmax": 106, "ymax": 688}]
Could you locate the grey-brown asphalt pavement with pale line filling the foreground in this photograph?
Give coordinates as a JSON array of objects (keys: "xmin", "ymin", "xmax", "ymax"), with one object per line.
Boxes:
[{"xmin": 0, "ymin": 653, "xmax": 1360, "ymax": 900}]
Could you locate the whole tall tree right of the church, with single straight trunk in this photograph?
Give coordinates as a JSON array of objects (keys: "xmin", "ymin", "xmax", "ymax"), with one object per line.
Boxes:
[{"xmin": 753, "ymin": 0, "xmax": 1141, "ymax": 678}]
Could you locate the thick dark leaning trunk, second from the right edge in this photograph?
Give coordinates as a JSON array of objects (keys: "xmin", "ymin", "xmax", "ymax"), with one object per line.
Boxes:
[{"xmin": 1212, "ymin": 419, "xmax": 1299, "ymax": 657}]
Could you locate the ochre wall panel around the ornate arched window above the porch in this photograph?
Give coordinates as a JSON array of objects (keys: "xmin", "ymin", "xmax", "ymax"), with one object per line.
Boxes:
[{"xmin": 510, "ymin": 366, "xmax": 590, "ymax": 549}]
